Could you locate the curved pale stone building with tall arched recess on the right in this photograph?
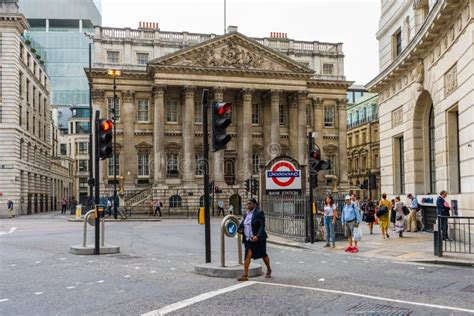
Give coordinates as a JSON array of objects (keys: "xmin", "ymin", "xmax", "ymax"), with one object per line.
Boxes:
[{"xmin": 368, "ymin": 0, "xmax": 474, "ymax": 224}]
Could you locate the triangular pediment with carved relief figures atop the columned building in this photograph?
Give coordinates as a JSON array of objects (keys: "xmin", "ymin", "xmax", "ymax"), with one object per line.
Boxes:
[{"xmin": 149, "ymin": 32, "xmax": 314, "ymax": 74}]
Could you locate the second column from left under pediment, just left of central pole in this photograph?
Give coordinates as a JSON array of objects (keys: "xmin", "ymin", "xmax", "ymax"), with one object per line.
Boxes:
[{"xmin": 182, "ymin": 86, "xmax": 195, "ymax": 182}]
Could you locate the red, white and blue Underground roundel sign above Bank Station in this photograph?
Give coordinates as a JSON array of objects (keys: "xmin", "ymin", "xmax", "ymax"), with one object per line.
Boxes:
[{"xmin": 265, "ymin": 160, "xmax": 301, "ymax": 191}]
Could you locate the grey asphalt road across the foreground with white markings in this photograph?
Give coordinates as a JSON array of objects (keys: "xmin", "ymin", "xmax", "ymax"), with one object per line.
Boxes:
[{"xmin": 0, "ymin": 215, "xmax": 474, "ymax": 315}]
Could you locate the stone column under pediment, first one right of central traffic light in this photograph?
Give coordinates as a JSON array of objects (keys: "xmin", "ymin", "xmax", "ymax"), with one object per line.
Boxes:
[{"xmin": 238, "ymin": 89, "xmax": 254, "ymax": 180}]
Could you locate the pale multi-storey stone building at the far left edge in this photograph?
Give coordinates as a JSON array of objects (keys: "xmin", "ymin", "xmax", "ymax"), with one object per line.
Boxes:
[{"xmin": 0, "ymin": 1, "xmax": 71, "ymax": 217}]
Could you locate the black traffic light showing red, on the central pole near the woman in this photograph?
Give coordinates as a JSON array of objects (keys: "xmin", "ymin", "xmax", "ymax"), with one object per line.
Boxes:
[{"xmin": 212, "ymin": 102, "xmax": 232, "ymax": 151}]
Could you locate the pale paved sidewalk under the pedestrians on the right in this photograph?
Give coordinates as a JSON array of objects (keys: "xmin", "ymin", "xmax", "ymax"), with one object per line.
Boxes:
[{"xmin": 268, "ymin": 223, "xmax": 474, "ymax": 267}]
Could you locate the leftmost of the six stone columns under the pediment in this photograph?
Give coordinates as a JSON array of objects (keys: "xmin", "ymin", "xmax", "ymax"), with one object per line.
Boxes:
[{"xmin": 153, "ymin": 85, "xmax": 166, "ymax": 185}]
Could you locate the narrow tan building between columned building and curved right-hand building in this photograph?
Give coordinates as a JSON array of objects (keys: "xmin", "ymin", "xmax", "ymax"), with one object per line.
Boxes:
[{"xmin": 347, "ymin": 93, "xmax": 380, "ymax": 200}]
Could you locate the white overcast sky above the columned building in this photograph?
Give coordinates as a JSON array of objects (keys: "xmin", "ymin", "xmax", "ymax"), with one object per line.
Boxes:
[{"xmin": 102, "ymin": 0, "xmax": 380, "ymax": 84}]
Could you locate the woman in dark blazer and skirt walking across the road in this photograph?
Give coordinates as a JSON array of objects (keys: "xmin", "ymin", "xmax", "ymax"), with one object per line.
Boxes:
[{"xmin": 237, "ymin": 199, "xmax": 272, "ymax": 281}]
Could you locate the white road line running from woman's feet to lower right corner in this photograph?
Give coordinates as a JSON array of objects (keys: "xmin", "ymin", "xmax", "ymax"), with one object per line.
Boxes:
[{"xmin": 254, "ymin": 281, "xmax": 474, "ymax": 314}]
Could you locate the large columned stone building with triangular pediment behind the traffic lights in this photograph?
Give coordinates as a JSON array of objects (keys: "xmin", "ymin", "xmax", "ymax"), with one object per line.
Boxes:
[{"xmin": 91, "ymin": 27, "xmax": 351, "ymax": 210}]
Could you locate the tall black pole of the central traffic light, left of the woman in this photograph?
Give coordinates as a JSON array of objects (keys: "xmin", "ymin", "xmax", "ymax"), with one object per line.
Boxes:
[{"xmin": 201, "ymin": 89, "xmax": 211, "ymax": 263}]
